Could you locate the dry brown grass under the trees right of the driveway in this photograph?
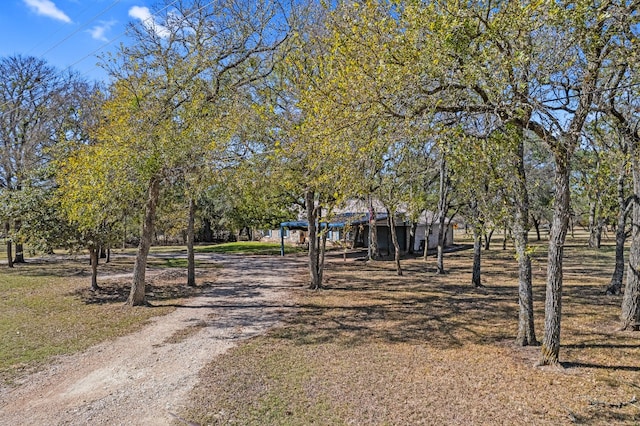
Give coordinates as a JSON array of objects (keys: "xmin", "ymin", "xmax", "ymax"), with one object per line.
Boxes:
[{"xmin": 183, "ymin": 240, "xmax": 640, "ymax": 425}]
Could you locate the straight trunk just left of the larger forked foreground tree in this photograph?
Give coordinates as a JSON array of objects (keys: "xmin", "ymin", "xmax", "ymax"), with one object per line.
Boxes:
[{"xmin": 504, "ymin": 134, "xmax": 538, "ymax": 346}]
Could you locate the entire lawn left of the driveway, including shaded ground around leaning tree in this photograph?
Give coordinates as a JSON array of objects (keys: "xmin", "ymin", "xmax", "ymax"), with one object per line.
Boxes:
[{"xmin": 0, "ymin": 251, "xmax": 216, "ymax": 385}]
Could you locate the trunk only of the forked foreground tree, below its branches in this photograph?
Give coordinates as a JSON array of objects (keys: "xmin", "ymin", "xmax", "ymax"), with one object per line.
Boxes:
[{"xmin": 539, "ymin": 150, "xmax": 570, "ymax": 365}]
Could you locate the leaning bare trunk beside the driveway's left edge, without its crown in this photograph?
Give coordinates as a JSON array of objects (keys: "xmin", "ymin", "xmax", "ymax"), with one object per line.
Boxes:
[{"xmin": 127, "ymin": 176, "xmax": 160, "ymax": 306}]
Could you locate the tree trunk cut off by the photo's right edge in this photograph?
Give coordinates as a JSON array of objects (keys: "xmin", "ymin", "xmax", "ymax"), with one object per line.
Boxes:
[{"xmin": 620, "ymin": 138, "xmax": 640, "ymax": 331}]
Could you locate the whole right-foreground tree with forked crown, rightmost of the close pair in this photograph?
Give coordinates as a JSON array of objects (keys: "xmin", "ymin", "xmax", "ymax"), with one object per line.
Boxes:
[{"xmin": 529, "ymin": 2, "xmax": 638, "ymax": 365}]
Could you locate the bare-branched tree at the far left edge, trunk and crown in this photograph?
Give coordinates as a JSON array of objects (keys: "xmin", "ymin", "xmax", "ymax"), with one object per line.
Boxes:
[{"xmin": 0, "ymin": 55, "xmax": 88, "ymax": 266}]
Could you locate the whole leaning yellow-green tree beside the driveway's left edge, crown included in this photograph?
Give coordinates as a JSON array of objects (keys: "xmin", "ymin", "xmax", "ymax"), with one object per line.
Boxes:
[{"xmin": 95, "ymin": 0, "xmax": 288, "ymax": 305}]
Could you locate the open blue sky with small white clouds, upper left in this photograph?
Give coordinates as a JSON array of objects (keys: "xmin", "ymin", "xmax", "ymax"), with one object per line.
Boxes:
[{"xmin": 0, "ymin": 0, "xmax": 162, "ymax": 80}]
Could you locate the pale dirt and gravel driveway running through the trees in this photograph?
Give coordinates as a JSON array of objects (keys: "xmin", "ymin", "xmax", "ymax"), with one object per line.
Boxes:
[{"xmin": 0, "ymin": 256, "xmax": 302, "ymax": 425}]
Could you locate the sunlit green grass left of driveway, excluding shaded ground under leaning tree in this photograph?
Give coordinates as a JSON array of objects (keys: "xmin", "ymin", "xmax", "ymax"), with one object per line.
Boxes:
[{"xmin": 0, "ymin": 265, "xmax": 173, "ymax": 380}]
